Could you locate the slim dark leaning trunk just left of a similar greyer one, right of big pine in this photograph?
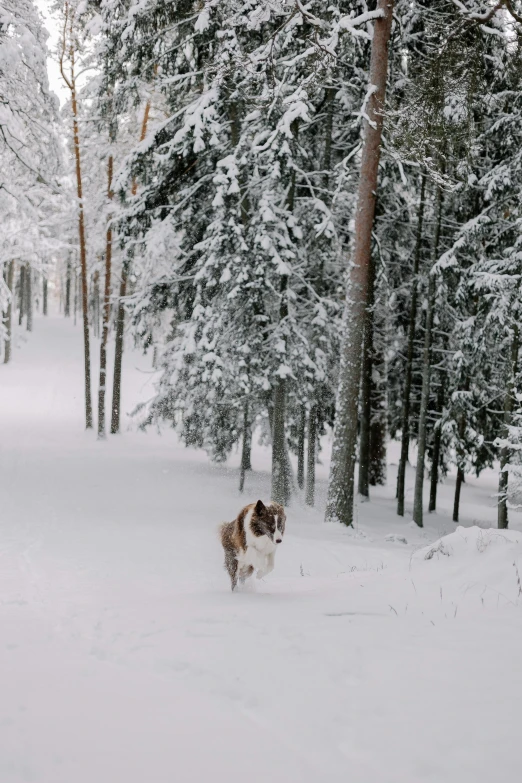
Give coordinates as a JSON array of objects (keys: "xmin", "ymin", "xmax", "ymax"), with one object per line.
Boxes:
[{"xmin": 397, "ymin": 174, "xmax": 426, "ymax": 517}]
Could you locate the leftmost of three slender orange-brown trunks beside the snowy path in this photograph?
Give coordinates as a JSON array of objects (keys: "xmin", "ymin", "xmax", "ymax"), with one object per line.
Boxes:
[{"xmin": 60, "ymin": 2, "xmax": 93, "ymax": 429}]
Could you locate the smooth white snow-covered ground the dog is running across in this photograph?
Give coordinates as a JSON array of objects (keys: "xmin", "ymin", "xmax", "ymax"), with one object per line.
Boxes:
[{"xmin": 0, "ymin": 317, "xmax": 522, "ymax": 783}]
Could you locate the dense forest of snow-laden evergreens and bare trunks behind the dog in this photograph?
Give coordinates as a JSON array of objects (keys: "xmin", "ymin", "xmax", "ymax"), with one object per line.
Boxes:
[{"xmin": 0, "ymin": 0, "xmax": 522, "ymax": 528}]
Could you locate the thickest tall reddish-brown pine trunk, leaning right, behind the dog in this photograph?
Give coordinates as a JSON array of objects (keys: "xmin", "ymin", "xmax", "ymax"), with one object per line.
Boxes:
[{"xmin": 326, "ymin": 0, "xmax": 393, "ymax": 525}]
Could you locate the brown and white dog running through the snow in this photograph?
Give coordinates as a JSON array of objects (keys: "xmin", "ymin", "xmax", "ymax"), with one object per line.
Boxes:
[{"xmin": 219, "ymin": 500, "xmax": 286, "ymax": 590}]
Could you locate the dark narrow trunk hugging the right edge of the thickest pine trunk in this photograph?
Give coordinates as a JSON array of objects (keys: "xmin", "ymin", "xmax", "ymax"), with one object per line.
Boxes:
[{"xmin": 358, "ymin": 257, "xmax": 375, "ymax": 499}]
